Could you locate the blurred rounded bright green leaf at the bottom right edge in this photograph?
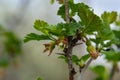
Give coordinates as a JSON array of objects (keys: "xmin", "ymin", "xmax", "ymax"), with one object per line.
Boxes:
[{"xmin": 90, "ymin": 65, "xmax": 108, "ymax": 80}]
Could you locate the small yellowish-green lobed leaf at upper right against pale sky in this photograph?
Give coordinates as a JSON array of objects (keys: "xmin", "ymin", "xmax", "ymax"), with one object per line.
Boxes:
[{"xmin": 101, "ymin": 11, "xmax": 117, "ymax": 24}]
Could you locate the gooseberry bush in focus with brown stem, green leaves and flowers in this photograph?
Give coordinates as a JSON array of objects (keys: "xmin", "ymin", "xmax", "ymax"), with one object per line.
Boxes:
[{"xmin": 24, "ymin": 0, "xmax": 120, "ymax": 80}]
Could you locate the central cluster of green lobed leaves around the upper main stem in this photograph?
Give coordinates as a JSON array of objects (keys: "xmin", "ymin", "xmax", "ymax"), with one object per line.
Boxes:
[{"xmin": 24, "ymin": 1, "xmax": 104, "ymax": 57}]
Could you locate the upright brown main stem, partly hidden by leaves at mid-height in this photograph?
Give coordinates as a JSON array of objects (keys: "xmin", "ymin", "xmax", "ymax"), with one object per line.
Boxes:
[{"xmin": 64, "ymin": 0, "xmax": 76, "ymax": 80}]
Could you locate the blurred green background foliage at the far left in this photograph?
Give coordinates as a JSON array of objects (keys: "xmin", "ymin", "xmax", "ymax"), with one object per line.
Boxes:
[{"xmin": 0, "ymin": 25, "xmax": 22, "ymax": 69}]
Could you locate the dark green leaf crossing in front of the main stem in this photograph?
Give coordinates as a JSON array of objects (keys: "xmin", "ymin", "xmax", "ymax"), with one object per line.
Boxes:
[{"xmin": 47, "ymin": 23, "xmax": 81, "ymax": 37}]
